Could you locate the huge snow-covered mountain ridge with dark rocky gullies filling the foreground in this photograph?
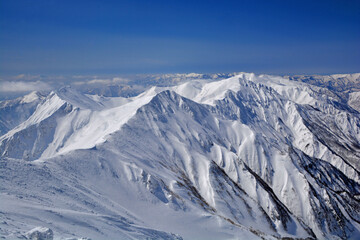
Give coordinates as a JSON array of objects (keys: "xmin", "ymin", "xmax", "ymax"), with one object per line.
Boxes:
[{"xmin": 0, "ymin": 74, "xmax": 360, "ymax": 239}]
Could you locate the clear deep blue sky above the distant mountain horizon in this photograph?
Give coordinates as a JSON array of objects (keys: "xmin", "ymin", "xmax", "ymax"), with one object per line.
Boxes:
[{"xmin": 0, "ymin": 0, "xmax": 360, "ymax": 74}]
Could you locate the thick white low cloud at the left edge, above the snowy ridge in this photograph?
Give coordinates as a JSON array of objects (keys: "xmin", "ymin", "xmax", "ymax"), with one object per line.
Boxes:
[{"xmin": 0, "ymin": 81, "xmax": 51, "ymax": 93}]
